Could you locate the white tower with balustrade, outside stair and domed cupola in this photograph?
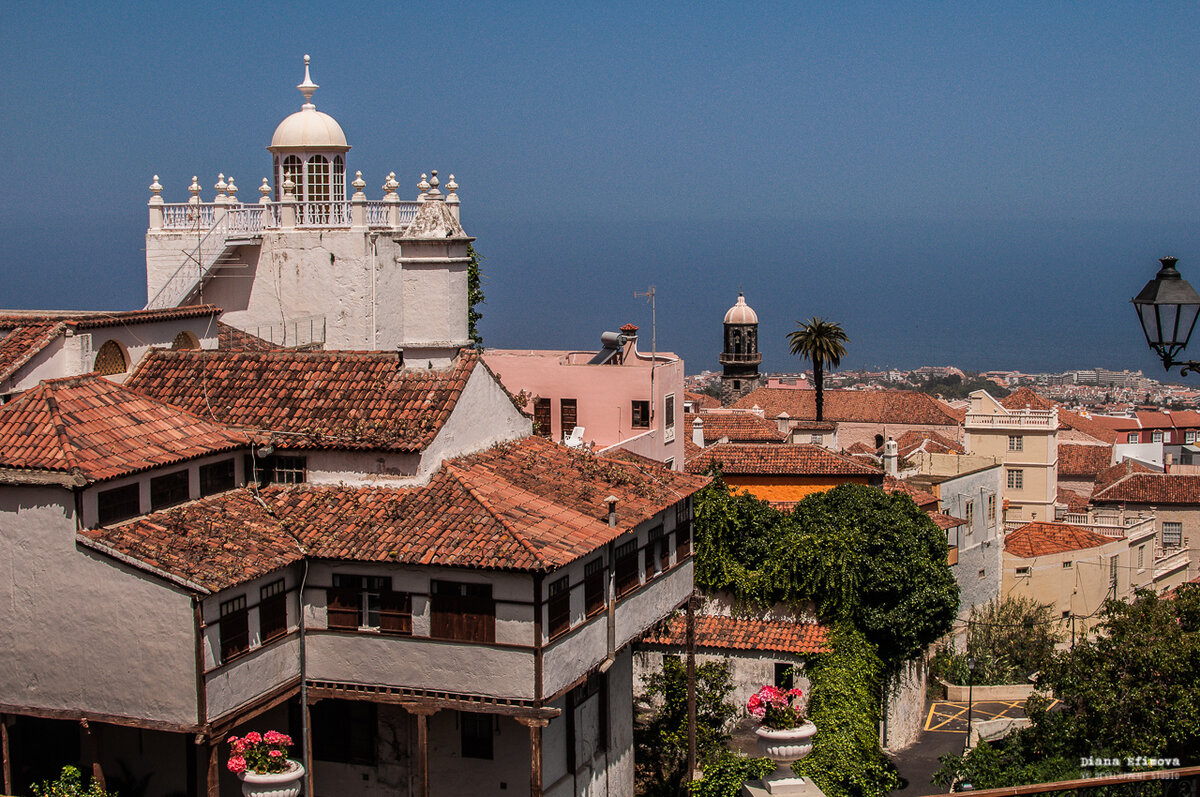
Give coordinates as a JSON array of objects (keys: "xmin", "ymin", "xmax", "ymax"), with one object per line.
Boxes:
[{"xmin": 146, "ymin": 55, "xmax": 474, "ymax": 366}]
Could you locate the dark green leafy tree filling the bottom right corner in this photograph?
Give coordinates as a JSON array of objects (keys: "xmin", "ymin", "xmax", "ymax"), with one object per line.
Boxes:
[{"xmin": 935, "ymin": 585, "xmax": 1200, "ymax": 789}]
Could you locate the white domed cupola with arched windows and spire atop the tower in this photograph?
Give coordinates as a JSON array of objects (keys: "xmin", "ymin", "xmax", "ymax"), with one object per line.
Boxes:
[{"xmin": 266, "ymin": 55, "xmax": 350, "ymax": 202}]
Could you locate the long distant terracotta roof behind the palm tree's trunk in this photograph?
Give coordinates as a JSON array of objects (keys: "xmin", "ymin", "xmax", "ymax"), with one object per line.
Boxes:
[{"xmin": 733, "ymin": 388, "xmax": 965, "ymax": 426}]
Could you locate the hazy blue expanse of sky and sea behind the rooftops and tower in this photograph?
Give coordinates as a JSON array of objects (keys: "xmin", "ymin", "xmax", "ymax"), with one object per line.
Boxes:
[{"xmin": 0, "ymin": 2, "xmax": 1200, "ymax": 376}]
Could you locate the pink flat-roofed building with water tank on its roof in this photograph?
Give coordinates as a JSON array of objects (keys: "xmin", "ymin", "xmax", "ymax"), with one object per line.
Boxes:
[{"xmin": 484, "ymin": 324, "xmax": 686, "ymax": 471}]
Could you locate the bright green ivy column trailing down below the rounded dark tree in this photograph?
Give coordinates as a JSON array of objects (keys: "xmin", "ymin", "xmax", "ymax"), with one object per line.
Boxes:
[{"xmin": 793, "ymin": 623, "xmax": 900, "ymax": 797}]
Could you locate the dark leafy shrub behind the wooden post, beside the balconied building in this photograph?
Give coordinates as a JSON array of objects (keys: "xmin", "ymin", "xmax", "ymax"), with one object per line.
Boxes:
[{"xmin": 634, "ymin": 657, "xmax": 737, "ymax": 797}]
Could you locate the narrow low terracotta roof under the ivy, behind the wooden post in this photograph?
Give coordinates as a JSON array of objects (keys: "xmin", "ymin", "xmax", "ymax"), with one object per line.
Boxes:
[{"xmin": 642, "ymin": 613, "xmax": 828, "ymax": 654}]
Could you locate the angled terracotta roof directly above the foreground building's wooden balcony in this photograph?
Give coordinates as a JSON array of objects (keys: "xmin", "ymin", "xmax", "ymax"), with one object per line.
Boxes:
[{"xmin": 85, "ymin": 437, "xmax": 708, "ymax": 589}]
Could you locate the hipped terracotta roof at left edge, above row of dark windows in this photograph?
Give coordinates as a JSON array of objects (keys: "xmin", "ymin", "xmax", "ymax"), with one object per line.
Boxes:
[{"xmin": 0, "ymin": 374, "xmax": 248, "ymax": 480}]
